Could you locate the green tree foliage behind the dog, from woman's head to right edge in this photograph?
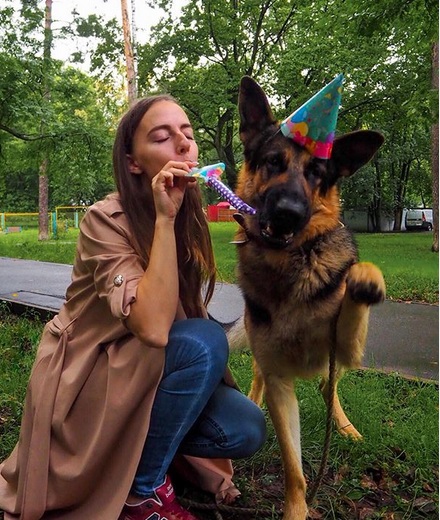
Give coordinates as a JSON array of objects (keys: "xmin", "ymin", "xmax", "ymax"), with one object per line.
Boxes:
[{"xmin": 139, "ymin": 0, "xmax": 438, "ymax": 222}]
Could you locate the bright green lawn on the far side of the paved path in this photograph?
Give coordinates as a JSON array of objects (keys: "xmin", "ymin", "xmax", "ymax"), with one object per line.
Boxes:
[{"xmin": 0, "ymin": 222, "xmax": 439, "ymax": 304}]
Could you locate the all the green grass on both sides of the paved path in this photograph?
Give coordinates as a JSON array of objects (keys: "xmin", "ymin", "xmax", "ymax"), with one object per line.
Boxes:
[{"xmin": 0, "ymin": 223, "xmax": 439, "ymax": 520}]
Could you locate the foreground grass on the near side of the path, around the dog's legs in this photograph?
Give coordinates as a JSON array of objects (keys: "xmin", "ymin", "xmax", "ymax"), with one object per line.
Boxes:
[{"xmin": 0, "ymin": 306, "xmax": 439, "ymax": 520}]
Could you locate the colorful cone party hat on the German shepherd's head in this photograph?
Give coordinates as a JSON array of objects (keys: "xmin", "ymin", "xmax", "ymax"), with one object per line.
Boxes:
[{"xmin": 280, "ymin": 74, "xmax": 344, "ymax": 159}]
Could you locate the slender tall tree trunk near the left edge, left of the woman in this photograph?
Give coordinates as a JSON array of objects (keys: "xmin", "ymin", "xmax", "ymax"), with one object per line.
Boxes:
[{"xmin": 38, "ymin": 0, "xmax": 52, "ymax": 240}]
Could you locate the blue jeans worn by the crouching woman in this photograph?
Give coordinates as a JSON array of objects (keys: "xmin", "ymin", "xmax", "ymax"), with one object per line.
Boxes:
[{"xmin": 131, "ymin": 318, "xmax": 266, "ymax": 497}]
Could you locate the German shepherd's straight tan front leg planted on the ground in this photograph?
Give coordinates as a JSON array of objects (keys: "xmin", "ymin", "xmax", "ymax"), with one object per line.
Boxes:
[{"xmin": 264, "ymin": 374, "xmax": 307, "ymax": 520}]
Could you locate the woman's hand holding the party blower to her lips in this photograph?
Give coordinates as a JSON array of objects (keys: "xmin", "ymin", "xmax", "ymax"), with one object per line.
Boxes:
[{"xmin": 151, "ymin": 161, "xmax": 197, "ymax": 219}]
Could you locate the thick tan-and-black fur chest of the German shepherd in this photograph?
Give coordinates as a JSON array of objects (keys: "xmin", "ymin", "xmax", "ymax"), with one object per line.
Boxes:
[{"xmin": 235, "ymin": 230, "xmax": 356, "ymax": 376}]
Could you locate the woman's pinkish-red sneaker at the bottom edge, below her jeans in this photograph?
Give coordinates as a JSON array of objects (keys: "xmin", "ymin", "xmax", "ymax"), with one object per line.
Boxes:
[{"xmin": 118, "ymin": 475, "xmax": 197, "ymax": 520}]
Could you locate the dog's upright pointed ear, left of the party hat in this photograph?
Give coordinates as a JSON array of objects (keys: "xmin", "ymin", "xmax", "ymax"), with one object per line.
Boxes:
[{"xmin": 238, "ymin": 76, "xmax": 277, "ymax": 143}]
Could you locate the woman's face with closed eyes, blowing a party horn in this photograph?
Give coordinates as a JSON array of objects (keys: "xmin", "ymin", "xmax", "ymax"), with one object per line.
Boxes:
[{"xmin": 128, "ymin": 100, "xmax": 198, "ymax": 179}]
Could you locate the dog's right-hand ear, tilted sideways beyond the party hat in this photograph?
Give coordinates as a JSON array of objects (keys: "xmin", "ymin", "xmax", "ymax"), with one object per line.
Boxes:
[{"xmin": 331, "ymin": 130, "xmax": 384, "ymax": 177}]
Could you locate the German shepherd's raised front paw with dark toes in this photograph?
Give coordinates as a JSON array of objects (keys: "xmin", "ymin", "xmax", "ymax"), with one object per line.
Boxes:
[{"xmin": 347, "ymin": 262, "xmax": 386, "ymax": 305}]
